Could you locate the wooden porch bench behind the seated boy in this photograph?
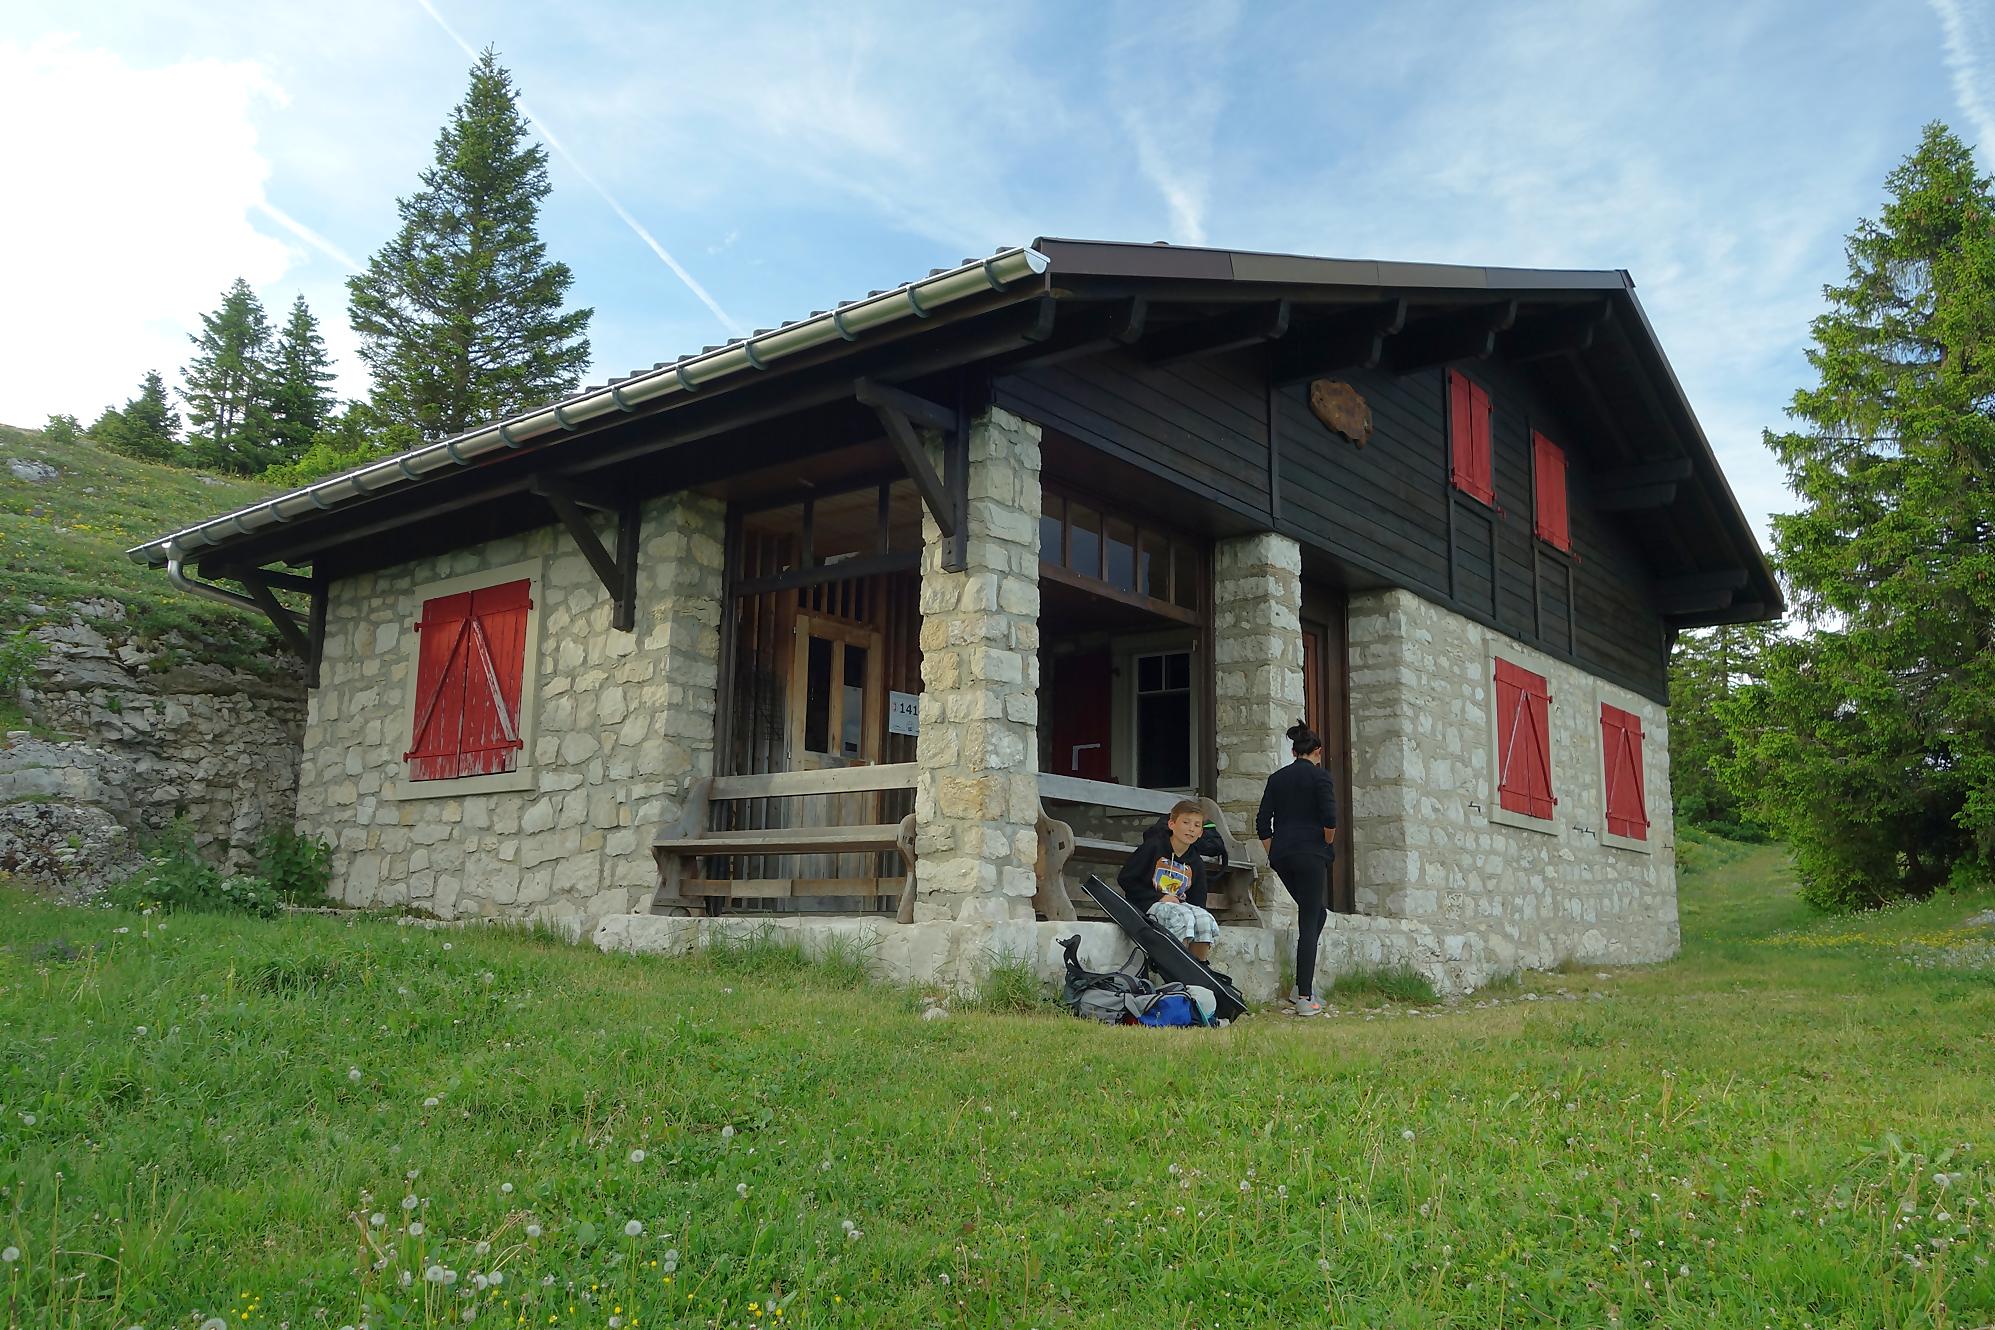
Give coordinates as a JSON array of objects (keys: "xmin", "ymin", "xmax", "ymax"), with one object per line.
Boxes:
[{"xmin": 1033, "ymin": 772, "xmax": 1261, "ymax": 927}]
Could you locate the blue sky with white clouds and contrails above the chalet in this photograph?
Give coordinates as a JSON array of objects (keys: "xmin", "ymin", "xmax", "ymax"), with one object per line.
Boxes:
[{"xmin": 0, "ymin": 0, "xmax": 1995, "ymax": 550}]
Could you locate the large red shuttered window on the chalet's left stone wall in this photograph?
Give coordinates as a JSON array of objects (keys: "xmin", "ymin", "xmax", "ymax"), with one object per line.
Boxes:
[{"xmin": 403, "ymin": 578, "xmax": 533, "ymax": 782}]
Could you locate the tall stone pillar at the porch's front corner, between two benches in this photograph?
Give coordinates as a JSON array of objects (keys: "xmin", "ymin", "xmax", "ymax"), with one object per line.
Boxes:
[{"xmin": 914, "ymin": 407, "xmax": 1039, "ymax": 921}]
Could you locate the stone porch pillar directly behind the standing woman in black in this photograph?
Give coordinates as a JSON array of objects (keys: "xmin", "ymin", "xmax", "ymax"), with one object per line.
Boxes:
[{"xmin": 1213, "ymin": 530, "xmax": 1303, "ymax": 925}]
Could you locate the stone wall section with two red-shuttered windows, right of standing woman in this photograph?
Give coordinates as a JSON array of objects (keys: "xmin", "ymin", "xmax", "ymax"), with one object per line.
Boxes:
[{"xmin": 1331, "ymin": 590, "xmax": 1678, "ymax": 973}]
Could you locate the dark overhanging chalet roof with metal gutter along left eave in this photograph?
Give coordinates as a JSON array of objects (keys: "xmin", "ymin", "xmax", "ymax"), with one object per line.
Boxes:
[{"xmin": 128, "ymin": 237, "xmax": 1782, "ymax": 626}]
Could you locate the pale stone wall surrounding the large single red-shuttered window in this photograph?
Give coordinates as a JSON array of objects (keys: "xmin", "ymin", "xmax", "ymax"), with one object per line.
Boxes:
[{"xmin": 297, "ymin": 495, "xmax": 724, "ymax": 927}]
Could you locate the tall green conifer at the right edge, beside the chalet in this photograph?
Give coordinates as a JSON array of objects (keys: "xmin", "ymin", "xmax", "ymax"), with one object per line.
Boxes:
[{"xmin": 1722, "ymin": 124, "xmax": 1995, "ymax": 907}]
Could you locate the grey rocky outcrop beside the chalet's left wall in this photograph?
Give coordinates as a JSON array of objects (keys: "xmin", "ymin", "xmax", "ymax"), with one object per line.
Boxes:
[{"xmin": 0, "ymin": 602, "xmax": 305, "ymax": 889}]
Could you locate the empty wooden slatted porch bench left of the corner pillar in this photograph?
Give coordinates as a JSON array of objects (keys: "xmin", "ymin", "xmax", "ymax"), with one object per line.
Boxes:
[{"xmin": 640, "ymin": 762, "xmax": 918, "ymax": 923}]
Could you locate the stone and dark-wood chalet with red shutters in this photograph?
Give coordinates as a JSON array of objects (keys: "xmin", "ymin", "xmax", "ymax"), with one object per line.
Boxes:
[{"xmin": 132, "ymin": 239, "xmax": 1780, "ymax": 997}]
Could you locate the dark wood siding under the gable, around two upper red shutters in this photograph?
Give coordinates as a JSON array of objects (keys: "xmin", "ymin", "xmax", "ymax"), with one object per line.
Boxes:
[{"xmin": 994, "ymin": 353, "xmax": 1666, "ymax": 700}]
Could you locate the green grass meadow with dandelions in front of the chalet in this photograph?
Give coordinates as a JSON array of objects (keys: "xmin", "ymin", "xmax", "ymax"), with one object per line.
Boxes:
[{"xmin": 0, "ymin": 847, "xmax": 1995, "ymax": 1330}]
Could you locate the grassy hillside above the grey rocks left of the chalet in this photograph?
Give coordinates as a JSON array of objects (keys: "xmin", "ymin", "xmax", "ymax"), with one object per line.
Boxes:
[{"xmin": 0, "ymin": 425, "xmax": 275, "ymax": 666}]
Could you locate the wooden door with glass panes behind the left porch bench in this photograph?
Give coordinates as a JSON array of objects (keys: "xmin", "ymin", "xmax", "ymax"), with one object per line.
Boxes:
[{"xmin": 786, "ymin": 612, "xmax": 886, "ymax": 877}]
